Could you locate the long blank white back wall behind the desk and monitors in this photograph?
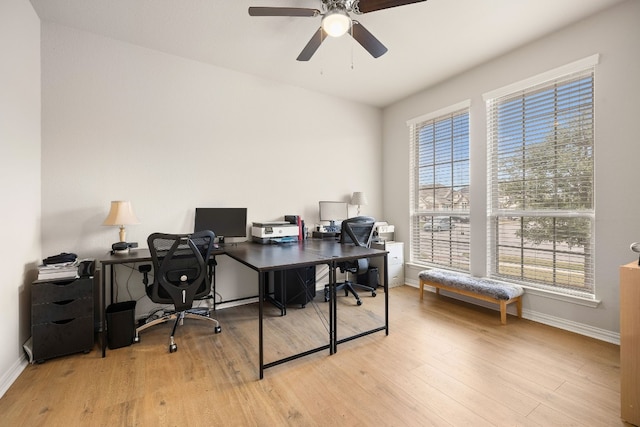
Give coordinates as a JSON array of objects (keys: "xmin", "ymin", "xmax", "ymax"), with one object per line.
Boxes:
[{"xmin": 42, "ymin": 23, "xmax": 382, "ymax": 314}]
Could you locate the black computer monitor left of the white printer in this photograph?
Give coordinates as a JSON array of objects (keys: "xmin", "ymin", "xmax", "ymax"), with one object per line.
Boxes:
[{"xmin": 193, "ymin": 208, "xmax": 247, "ymax": 238}]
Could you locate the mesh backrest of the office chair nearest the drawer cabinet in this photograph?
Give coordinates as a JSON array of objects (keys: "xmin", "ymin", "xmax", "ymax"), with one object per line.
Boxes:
[{"xmin": 147, "ymin": 230, "xmax": 215, "ymax": 311}]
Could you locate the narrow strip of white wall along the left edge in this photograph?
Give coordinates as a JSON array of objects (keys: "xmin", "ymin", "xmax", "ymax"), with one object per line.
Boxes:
[{"xmin": 0, "ymin": 0, "xmax": 41, "ymax": 396}]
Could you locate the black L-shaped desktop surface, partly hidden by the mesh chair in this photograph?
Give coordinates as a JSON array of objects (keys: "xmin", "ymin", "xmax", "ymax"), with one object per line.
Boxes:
[{"xmin": 100, "ymin": 239, "xmax": 388, "ymax": 271}]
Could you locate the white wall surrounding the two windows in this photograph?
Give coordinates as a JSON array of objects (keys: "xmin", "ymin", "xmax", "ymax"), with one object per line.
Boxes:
[{"xmin": 383, "ymin": 0, "xmax": 640, "ymax": 340}]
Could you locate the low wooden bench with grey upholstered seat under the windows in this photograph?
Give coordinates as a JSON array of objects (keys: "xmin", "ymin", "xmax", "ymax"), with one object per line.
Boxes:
[{"xmin": 418, "ymin": 268, "xmax": 524, "ymax": 325}]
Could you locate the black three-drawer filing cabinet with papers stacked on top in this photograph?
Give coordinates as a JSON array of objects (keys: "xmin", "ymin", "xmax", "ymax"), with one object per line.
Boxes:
[{"xmin": 31, "ymin": 277, "xmax": 94, "ymax": 362}]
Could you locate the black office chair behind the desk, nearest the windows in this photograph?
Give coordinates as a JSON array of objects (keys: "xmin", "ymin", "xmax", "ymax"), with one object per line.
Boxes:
[{"xmin": 324, "ymin": 216, "xmax": 376, "ymax": 305}]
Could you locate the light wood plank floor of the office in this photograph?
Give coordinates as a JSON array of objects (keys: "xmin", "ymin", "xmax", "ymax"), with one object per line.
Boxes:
[{"xmin": 0, "ymin": 286, "xmax": 625, "ymax": 427}]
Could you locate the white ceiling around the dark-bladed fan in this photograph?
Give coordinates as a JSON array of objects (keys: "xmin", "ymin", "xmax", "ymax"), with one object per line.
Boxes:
[{"xmin": 30, "ymin": 0, "xmax": 623, "ymax": 107}]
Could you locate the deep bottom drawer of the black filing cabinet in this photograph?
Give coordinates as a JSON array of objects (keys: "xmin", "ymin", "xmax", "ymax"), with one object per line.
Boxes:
[{"xmin": 31, "ymin": 317, "xmax": 94, "ymax": 362}]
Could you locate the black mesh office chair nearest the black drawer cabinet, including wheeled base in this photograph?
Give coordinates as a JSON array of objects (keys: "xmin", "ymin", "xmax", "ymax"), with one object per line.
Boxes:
[{"xmin": 134, "ymin": 230, "xmax": 222, "ymax": 353}]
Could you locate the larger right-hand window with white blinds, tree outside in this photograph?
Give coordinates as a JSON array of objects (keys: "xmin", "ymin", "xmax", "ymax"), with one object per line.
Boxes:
[{"xmin": 486, "ymin": 64, "xmax": 595, "ymax": 298}]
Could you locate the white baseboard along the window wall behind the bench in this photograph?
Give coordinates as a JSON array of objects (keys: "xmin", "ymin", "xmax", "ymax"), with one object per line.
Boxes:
[{"xmin": 406, "ymin": 280, "xmax": 620, "ymax": 345}]
